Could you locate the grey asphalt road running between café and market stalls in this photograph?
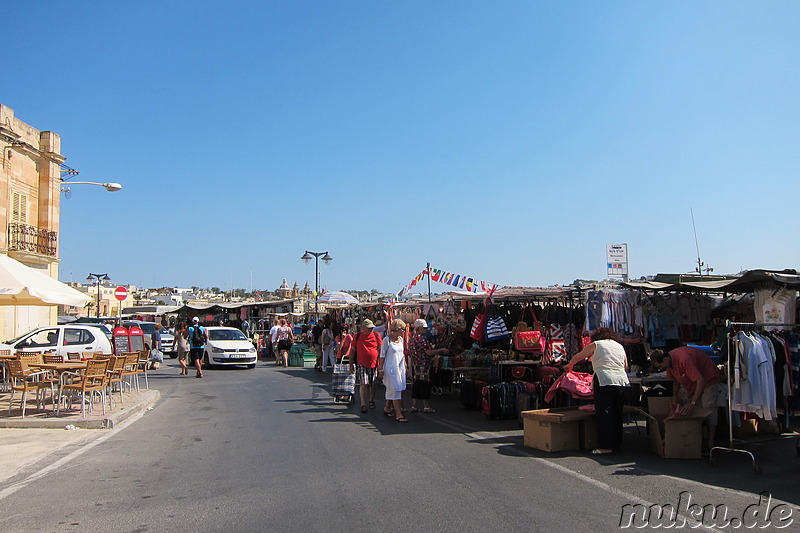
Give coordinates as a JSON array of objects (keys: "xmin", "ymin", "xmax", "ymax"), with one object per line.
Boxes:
[{"xmin": 0, "ymin": 363, "xmax": 800, "ymax": 532}]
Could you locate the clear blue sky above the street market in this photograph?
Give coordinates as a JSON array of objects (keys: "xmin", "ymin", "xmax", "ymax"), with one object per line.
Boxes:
[{"xmin": 0, "ymin": 0, "xmax": 800, "ymax": 291}]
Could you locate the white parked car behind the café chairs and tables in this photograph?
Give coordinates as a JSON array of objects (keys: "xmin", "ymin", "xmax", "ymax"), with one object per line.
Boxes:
[{"xmin": 0, "ymin": 324, "xmax": 112, "ymax": 358}]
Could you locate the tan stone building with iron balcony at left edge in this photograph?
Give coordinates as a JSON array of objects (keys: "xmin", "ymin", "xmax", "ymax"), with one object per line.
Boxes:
[{"xmin": 0, "ymin": 105, "xmax": 66, "ymax": 339}]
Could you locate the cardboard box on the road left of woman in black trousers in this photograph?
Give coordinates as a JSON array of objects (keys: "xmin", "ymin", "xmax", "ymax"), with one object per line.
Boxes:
[{"xmin": 522, "ymin": 407, "xmax": 597, "ymax": 452}]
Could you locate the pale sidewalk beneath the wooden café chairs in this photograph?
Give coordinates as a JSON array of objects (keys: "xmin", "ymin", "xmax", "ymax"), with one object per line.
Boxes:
[{"xmin": 0, "ymin": 390, "xmax": 161, "ymax": 481}]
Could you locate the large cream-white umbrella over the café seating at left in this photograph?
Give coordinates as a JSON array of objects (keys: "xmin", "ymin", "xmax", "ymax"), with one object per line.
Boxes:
[{"xmin": 0, "ymin": 254, "xmax": 91, "ymax": 307}]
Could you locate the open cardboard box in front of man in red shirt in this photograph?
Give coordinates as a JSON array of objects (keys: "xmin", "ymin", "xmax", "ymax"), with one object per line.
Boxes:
[{"xmin": 643, "ymin": 398, "xmax": 712, "ymax": 459}]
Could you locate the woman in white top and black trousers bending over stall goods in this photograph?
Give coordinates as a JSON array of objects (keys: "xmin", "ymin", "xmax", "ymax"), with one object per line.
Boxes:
[{"xmin": 564, "ymin": 328, "xmax": 630, "ymax": 455}]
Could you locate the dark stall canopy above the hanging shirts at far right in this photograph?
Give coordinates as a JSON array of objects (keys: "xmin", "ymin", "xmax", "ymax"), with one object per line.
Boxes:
[{"xmin": 621, "ymin": 270, "xmax": 800, "ymax": 293}]
